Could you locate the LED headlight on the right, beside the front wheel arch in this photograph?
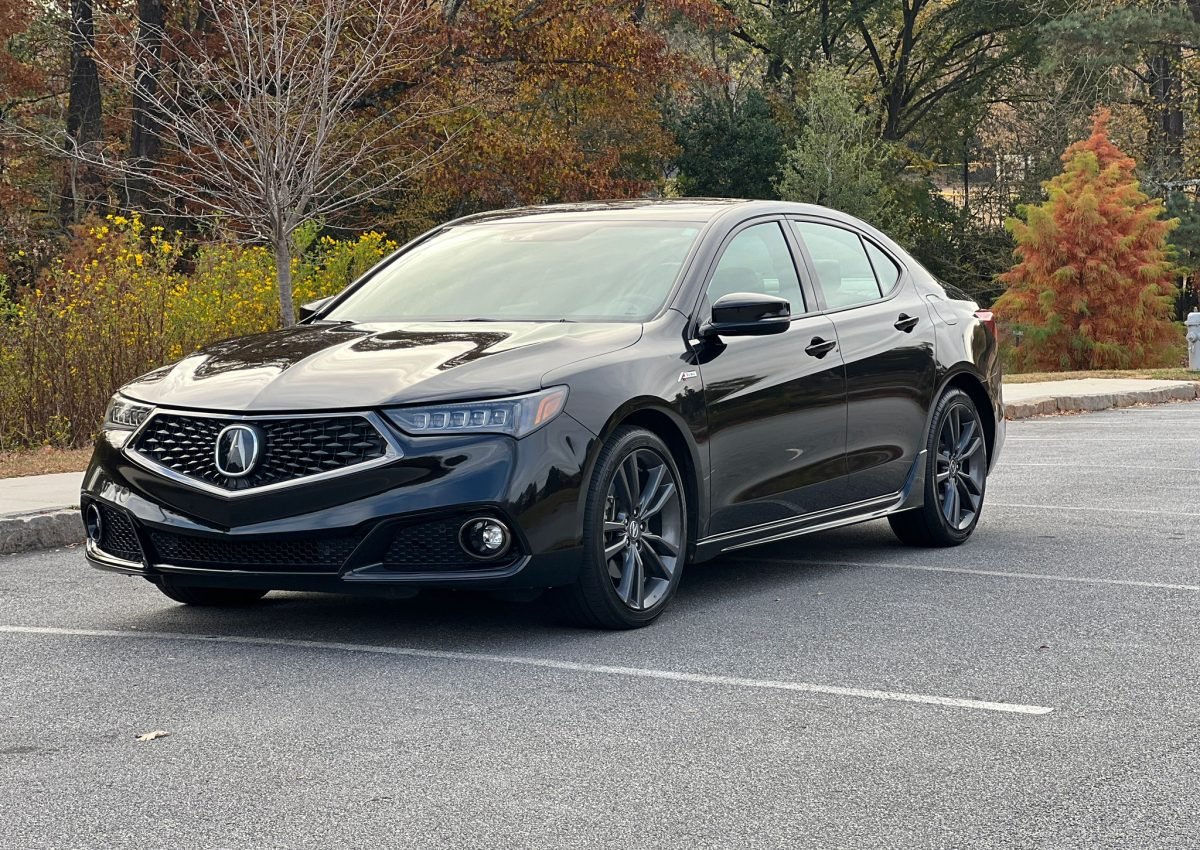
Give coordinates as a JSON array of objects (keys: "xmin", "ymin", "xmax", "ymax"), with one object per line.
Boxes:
[{"xmin": 386, "ymin": 387, "xmax": 566, "ymax": 437}]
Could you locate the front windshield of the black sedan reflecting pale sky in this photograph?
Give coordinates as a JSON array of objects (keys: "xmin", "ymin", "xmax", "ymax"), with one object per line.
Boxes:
[{"xmin": 323, "ymin": 221, "xmax": 700, "ymax": 322}]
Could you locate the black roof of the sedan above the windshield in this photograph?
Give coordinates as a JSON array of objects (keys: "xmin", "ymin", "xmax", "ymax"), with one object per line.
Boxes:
[{"xmin": 446, "ymin": 198, "xmax": 853, "ymax": 227}]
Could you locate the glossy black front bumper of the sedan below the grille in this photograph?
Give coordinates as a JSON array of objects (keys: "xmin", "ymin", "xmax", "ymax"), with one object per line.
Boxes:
[{"xmin": 80, "ymin": 414, "xmax": 595, "ymax": 593}]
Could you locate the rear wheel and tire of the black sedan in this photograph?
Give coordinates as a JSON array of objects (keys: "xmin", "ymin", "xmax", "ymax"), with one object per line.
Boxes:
[{"xmin": 888, "ymin": 389, "xmax": 988, "ymax": 546}]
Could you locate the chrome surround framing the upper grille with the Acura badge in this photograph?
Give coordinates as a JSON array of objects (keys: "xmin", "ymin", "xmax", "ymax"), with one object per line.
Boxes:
[{"xmin": 121, "ymin": 406, "xmax": 404, "ymax": 499}]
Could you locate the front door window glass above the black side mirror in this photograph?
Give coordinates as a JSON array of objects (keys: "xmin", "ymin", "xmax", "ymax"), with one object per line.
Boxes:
[{"xmin": 708, "ymin": 221, "xmax": 804, "ymax": 316}]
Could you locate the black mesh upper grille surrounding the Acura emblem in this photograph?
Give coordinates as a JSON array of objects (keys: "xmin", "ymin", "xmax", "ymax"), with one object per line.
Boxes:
[{"xmin": 133, "ymin": 413, "xmax": 388, "ymax": 491}]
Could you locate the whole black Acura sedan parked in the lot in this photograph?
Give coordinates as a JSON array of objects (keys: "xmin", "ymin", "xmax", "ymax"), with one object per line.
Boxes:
[{"xmin": 82, "ymin": 199, "xmax": 1004, "ymax": 628}]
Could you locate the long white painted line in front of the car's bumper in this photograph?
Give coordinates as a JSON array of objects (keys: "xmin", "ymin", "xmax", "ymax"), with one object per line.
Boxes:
[{"xmin": 0, "ymin": 625, "xmax": 1054, "ymax": 714}]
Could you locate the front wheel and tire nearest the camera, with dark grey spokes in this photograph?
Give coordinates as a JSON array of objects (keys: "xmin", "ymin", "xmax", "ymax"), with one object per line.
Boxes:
[{"xmin": 557, "ymin": 426, "xmax": 688, "ymax": 629}]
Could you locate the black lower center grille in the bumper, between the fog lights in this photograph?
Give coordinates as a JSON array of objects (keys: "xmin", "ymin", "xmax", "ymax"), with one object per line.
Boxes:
[{"xmin": 150, "ymin": 531, "xmax": 361, "ymax": 573}]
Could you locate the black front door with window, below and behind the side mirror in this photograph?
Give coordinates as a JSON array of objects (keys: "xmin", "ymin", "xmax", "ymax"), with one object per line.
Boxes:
[{"xmin": 697, "ymin": 220, "xmax": 846, "ymax": 534}]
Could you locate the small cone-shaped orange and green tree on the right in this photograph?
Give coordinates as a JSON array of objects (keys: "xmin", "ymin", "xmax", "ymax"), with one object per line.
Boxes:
[{"xmin": 994, "ymin": 109, "xmax": 1180, "ymax": 370}]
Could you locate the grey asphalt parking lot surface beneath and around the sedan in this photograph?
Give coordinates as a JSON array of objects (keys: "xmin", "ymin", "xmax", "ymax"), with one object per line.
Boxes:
[{"xmin": 0, "ymin": 402, "xmax": 1200, "ymax": 850}]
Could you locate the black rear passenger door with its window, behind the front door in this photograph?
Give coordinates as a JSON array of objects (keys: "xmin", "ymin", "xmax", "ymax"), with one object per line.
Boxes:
[{"xmin": 791, "ymin": 219, "xmax": 937, "ymax": 502}]
